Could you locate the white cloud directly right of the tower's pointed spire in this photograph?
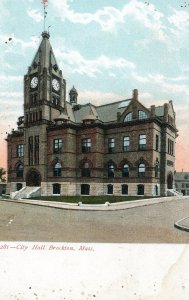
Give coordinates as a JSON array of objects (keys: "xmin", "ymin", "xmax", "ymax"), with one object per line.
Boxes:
[{"xmin": 55, "ymin": 49, "xmax": 135, "ymax": 77}]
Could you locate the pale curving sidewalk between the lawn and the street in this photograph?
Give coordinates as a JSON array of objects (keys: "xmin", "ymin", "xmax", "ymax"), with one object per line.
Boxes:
[{"xmin": 0, "ymin": 196, "xmax": 185, "ymax": 212}]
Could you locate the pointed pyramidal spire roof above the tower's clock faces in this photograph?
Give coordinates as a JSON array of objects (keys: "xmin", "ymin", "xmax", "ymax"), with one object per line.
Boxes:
[{"xmin": 29, "ymin": 31, "xmax": 61, "ymax": 74}]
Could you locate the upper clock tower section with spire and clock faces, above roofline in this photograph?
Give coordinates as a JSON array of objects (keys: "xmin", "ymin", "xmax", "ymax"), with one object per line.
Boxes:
[{"xmin": 24, "ymin": 31, "xmax": 66, "ymax": 126}]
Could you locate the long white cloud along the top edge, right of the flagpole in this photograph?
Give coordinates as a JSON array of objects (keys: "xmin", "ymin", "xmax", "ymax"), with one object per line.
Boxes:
[{"xmin": 52, "ymin": 0, "xmax": 165, "ymax": 40}]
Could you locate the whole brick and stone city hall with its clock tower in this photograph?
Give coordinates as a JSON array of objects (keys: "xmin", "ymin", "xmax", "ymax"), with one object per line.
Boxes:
[{"xmin": 7, "ymin": 31, "xmax": 177, "ymax": 196}]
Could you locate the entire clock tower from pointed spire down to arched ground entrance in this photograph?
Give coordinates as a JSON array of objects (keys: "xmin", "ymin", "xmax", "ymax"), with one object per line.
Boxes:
[{"xmin": 24, "ymin": 31, "xmax": 66, "ymax": 186}]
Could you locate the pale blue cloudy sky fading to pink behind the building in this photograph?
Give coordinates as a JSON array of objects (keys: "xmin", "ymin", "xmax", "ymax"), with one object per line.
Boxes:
[{"xmin": 0, "ymin": 0, "xmax": 189, "ymax": 171}]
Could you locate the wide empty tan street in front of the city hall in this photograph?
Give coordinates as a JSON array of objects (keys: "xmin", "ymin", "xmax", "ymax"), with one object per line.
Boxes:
[{"xmin": 0, "ymin": 198, "xmax": 189, "ymax": 243}]
